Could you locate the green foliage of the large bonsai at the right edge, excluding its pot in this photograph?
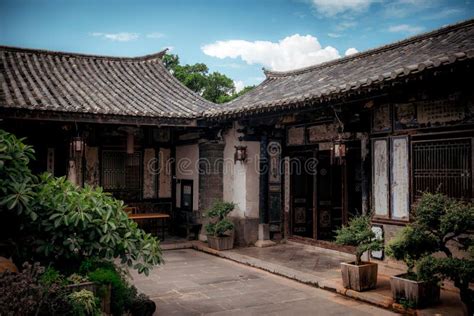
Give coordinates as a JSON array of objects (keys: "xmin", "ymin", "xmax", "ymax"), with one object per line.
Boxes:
[{"xmin": 387, "ymin": 192, "xmax": 474, "ymax": 314}]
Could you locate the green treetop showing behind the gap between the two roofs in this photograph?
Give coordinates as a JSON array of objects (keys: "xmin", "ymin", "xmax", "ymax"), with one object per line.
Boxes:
[{"xmin": 162, "ymin": 54, "xmax": 254, "ymax": 103}]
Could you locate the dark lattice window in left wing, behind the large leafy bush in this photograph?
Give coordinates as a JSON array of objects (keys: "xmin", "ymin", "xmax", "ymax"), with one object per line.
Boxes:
[{"xmin": 102, "ymin": 150, "xmax": 141, "ymax": 199}]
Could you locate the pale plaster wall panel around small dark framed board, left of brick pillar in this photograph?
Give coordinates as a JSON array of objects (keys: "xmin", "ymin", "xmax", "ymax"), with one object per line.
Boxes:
[{"xmin": 176, "ymin": 144, "xmax": 199, "ymax": 211}]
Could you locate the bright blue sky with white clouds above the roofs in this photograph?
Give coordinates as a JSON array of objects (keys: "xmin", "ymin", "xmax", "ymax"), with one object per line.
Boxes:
[{"xmin": 0, "ymin": 0, "xmax": 474, "ymax": 87}]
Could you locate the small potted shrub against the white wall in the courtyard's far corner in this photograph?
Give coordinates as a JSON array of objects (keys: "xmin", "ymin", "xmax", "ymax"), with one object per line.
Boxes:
[{"xmin": 205, "ymin": 201, "xmax": 235, "ymax": 250}]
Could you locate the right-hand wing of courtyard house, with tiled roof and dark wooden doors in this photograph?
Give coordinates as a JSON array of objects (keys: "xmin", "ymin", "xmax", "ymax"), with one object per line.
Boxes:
[{"xmin": 206, "ymin": 20, "xmax": 474, "ymax": 244}]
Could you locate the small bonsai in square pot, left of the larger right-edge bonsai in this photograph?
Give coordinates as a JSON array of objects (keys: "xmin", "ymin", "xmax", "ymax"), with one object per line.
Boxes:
[{"xmin": 336, "ymin": 215, "xmax": 383, "ymax": 292}]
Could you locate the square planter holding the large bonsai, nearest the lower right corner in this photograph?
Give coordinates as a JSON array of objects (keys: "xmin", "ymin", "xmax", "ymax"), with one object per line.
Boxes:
[{"xmin": 390, "ymin": 273, "xmax": 440, "ymax": 308}]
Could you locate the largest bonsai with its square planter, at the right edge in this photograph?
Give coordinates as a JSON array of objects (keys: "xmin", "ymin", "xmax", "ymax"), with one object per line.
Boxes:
[{"xmin": 387, "ymin": 192, "xmax": 474, "ymax": 306}]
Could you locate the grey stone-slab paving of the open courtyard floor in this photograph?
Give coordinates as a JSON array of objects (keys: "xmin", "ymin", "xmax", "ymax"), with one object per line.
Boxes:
[{"xmin": 132, "ymin": 249, "xmax": 393, "ymax": 316}]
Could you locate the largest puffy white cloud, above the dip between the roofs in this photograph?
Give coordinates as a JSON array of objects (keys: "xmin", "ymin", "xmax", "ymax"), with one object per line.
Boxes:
[{"xmin": 201, "ymin": 34, "xmax": 340, "ymax": 71}]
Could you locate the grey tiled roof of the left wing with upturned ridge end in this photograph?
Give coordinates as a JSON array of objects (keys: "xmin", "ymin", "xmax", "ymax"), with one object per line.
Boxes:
[{"xmin": 0, "ymin": 46, "xmax": 216, "ymax": 118}]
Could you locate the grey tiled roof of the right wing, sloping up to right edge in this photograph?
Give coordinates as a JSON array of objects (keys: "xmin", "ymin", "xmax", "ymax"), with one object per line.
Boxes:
[{"xmin": 205, "ymin": 20, "xmax": 474, "ymax": 118}]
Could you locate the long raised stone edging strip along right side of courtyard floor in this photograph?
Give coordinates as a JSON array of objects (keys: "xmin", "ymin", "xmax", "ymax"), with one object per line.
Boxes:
[{"xmin": 162, "ymin": 240, "xmax": 462, "ymax": 315}]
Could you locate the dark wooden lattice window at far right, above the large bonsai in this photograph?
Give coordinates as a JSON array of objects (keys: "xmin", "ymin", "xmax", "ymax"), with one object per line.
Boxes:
[{"xmin": 412, "ymin": 138, "xmax": 472, "ymax": 199}]
